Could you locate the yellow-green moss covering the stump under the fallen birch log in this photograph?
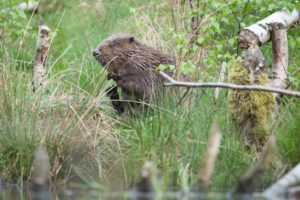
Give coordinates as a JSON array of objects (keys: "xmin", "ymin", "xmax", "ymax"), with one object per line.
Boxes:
[{"xmin": 229, "ymin": 58, "xmax": 276, "ymax": 147}]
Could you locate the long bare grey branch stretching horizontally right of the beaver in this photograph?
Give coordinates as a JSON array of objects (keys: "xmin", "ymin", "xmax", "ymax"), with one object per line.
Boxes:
[{"xmin": 159, "ymin": 72, "xmax": 300, "ymax": 98}]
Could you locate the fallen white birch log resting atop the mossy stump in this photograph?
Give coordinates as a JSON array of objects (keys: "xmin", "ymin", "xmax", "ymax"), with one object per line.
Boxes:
[{"xmin": 239, "ymin": 9, "xmax": 300, "ymax": 48}]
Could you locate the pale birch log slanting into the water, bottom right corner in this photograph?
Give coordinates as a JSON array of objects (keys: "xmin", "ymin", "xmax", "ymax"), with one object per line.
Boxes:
[{"xmin": 264, "ymin": 163, "xmax": 300, "ymax": 200}]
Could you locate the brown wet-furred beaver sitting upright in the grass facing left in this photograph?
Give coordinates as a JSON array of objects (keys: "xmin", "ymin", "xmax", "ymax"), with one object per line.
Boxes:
[{"xmin": 93, "ymin": 33, "xmax": 174, "ymax": 113}]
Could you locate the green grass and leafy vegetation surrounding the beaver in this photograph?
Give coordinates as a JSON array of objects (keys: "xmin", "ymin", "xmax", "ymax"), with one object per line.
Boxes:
[{"xmin": 0, "ymin": 0, "xmax": 300, "ymax": 190}]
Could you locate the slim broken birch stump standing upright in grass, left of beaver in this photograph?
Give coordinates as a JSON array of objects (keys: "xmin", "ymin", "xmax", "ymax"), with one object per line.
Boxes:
[{"xmin": 33, "ymin": 24, "xmax": 50, "ymax": 90}]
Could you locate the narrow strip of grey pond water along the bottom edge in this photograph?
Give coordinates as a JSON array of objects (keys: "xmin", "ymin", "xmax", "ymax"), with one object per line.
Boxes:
[{"xmin": 0, "ymin": 185, "xmax": 265, "ymax": 200}]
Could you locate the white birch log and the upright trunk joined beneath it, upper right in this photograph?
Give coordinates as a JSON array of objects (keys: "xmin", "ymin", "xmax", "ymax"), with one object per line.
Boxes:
[{"xmin": 239, "ymin": 9, "xmax": 300, "ymax": 93}]
